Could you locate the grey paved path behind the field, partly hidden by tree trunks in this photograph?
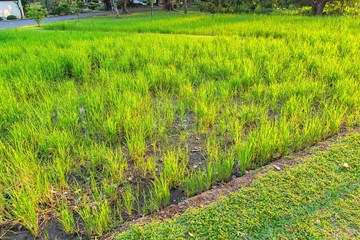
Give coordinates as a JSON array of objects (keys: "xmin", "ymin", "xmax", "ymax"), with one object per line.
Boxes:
[{"xmin": 0, "ymin": 7, "xmax": 160, "ymax": 29}]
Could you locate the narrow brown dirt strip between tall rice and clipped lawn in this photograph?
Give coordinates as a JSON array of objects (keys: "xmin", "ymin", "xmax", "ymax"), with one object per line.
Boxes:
[{"xmin": 101, "ymin": 127, "xmax": 360, "ymax": 239}]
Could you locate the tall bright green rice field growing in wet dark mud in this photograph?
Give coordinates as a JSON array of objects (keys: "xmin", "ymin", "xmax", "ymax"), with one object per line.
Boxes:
[{"xmin": 0, "ymin": 13, "xmax": 360, "ymax": 238}]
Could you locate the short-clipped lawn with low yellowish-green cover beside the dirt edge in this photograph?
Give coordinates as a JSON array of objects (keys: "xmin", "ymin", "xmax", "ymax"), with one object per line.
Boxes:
[{"xmin": 116, "ymin": 133, "xmax": 360, "ymax": 239}]
